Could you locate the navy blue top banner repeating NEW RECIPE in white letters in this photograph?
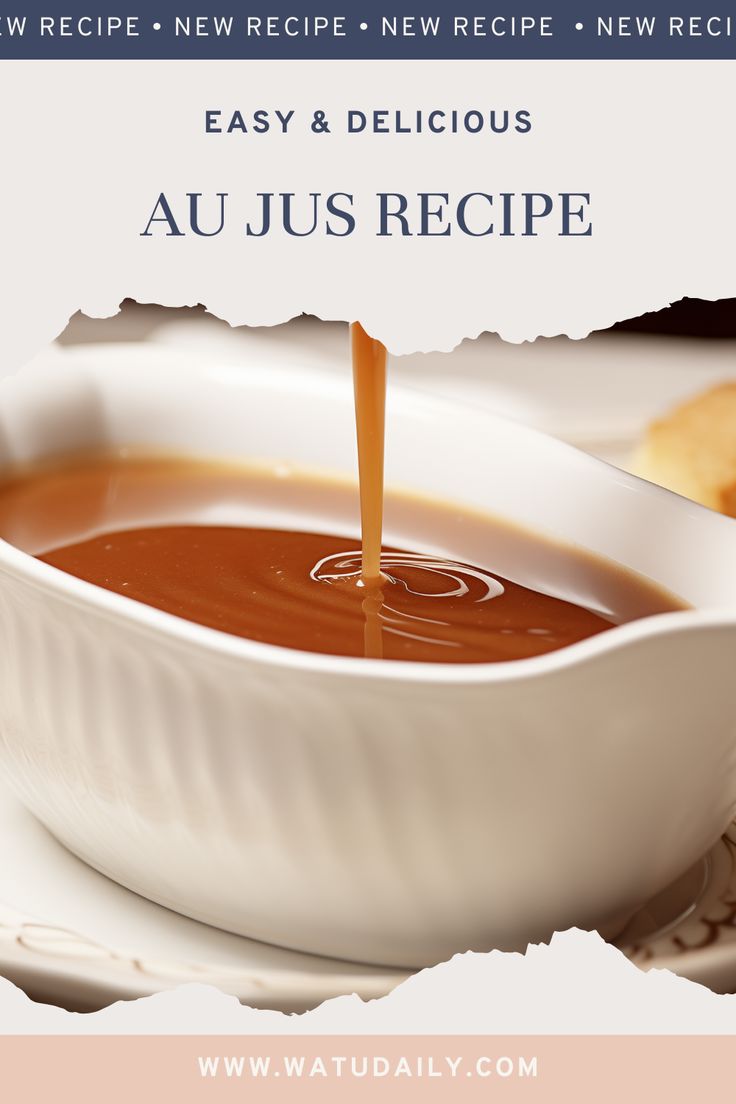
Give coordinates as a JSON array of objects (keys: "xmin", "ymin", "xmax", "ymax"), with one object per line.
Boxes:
[{"xmin": 0, "ymin": 0, "xmax": 736, "ymax": 60}]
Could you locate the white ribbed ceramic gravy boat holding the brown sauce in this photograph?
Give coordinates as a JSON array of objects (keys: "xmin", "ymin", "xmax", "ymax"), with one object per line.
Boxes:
[{"xmin": 0, "ymin": 346, "xmax": 736, "ymax": 966}]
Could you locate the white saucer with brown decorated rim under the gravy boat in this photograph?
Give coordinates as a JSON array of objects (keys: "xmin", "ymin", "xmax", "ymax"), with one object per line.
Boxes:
[{"xmin": 0, "ymin": 786, "xmax": 736, "ymax": 1011}]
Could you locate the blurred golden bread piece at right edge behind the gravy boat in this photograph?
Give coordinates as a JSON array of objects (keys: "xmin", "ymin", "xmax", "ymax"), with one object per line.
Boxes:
[{"xmin": 632, "ymin": 382, "xmax": 736, "ymax": 518}]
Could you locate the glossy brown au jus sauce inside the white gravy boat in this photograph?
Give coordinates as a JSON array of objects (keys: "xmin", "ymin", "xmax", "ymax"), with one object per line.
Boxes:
[{"xmin": 0, "ymin": 456, "xmax": 683, "ymax": 664}]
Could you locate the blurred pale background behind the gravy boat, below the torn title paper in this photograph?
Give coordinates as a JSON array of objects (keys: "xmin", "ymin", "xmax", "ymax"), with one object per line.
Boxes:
[{"xmin": 57, "ymin": 299, "xmax": 736, "ymax": 467}]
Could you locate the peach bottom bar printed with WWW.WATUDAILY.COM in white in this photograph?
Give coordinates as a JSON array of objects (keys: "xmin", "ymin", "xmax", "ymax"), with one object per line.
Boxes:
[{"xmin": 0, "ymin": 1036, "xmax": 734, "ymax": 1104}]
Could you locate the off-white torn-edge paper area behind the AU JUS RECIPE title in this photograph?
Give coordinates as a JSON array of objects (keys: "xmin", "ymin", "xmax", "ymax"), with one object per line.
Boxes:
[{"xmin": 0, "ymin": 61, "xmax": 736, "ymax": 370}]
